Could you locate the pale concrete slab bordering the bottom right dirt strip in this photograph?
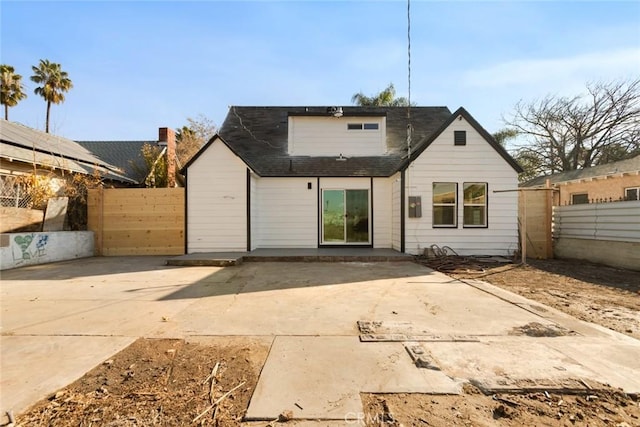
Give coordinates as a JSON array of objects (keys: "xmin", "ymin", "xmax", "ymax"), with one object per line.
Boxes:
[{"xmin": 421, "ymin": 337, "xmax": 640, "ymax": 392}]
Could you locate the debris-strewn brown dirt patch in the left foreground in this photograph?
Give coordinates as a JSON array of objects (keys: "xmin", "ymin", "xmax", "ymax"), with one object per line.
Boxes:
[{"xmin": 16, "ymin": 338, "xmax": 269, "ymax": 427}]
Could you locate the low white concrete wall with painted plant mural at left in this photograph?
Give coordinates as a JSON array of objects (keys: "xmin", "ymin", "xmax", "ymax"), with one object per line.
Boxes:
[{"xmin": 0, "ymin": 231, "xmax": 95, "ymax": 270}]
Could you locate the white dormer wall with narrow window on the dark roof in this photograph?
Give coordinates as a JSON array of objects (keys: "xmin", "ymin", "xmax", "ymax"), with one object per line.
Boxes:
[{"xmin": 289, "ymin": 116, "xmax": 387, "ymax": 157}]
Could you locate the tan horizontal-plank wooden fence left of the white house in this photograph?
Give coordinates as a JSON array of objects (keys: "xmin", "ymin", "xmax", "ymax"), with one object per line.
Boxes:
[{"xmin": 88, "ymin": 188, "xmax": 185, "ymax": 256}]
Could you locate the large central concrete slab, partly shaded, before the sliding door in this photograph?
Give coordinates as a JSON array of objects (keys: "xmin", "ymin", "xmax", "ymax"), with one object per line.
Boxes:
[{"xmin": 154, "ymin": 263, "xmax": 553, "ymax": 336}]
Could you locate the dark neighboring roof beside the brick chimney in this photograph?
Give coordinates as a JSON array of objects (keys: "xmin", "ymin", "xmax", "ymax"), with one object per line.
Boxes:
[{"xmin": 76, "ymin": 141, "xmax": 158, "ymax": 183}]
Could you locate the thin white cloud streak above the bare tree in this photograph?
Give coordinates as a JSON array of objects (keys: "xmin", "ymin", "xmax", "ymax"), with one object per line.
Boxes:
[{"xmin": 462, "ymin": 48, "xmax": 640, "ymax": 91}]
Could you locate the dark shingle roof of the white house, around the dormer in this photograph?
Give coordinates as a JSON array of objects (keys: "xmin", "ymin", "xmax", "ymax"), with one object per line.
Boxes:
[{"xmin": 185, "ymin": 106, "xmax": 522, "ymax": 177}]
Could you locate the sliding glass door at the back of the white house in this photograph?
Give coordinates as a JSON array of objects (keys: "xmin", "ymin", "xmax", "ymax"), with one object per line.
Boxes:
[{"xmin": 322, "ymin": 190, "xmax": 370, "ymax": 244}]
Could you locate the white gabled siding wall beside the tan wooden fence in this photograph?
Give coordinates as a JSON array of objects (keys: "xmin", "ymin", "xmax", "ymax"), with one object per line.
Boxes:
[{"xmin": 187, "ymin": 140, "xmax": 247, "ymax": 253}]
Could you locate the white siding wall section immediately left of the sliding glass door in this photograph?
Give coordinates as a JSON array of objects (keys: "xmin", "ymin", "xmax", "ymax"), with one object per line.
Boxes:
[{"xmin": 256, "ymin": 178, "xmax": 318, "ymax": 248}]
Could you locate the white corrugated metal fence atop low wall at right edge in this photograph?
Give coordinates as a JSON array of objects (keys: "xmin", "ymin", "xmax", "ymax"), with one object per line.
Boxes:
[{"xmin": 553, "ymin": 200, "xmax": 640, "ymax": 270}]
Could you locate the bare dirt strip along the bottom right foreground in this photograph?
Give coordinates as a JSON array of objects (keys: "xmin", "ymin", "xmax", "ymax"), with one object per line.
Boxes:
[{"xmin": 362, "ymin": 385, "xmax": 640, "ymax": 427}]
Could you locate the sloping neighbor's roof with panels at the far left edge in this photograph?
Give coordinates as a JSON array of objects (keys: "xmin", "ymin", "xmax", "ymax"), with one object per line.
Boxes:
[{"xmin": 0, "ymin": 119, "xmax": 134, "ymax": 183}]
